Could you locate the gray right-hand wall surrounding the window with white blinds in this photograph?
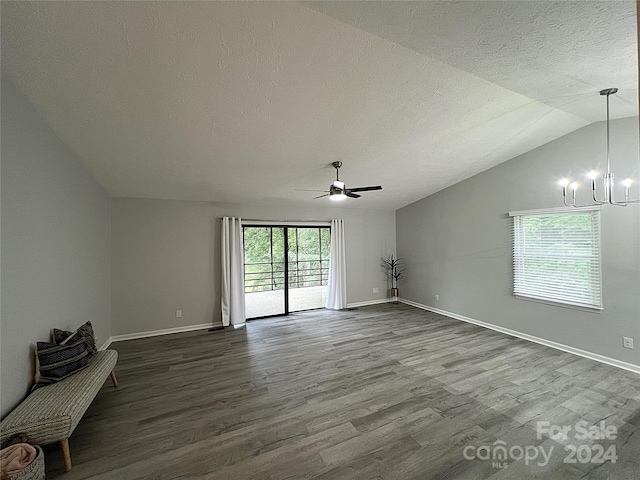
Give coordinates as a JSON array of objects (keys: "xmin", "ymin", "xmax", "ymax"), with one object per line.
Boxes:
[{"xmin": 396, "ymin": 117, "xmax": 640, "ymax": 365}]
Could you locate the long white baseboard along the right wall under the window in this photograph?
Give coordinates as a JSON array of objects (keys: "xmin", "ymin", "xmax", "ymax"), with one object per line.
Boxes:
[{"xmin": 398, "ymin": 298, "xmax": 640, "ymax": 374}]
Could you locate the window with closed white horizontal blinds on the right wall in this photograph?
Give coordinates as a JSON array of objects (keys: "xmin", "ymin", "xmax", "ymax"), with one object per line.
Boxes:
[{"xmin": 509, "ymin": 207, "xmax": 602, "ymax": 310}]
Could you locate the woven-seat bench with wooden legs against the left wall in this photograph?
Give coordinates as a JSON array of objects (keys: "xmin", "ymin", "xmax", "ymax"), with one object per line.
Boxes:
[{"xmin": 0, "ymin": 350, "xmax": 118, "ymax": 472}]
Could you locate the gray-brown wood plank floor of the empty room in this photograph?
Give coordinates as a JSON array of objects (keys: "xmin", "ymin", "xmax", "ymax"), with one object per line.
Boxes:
[{"xmin": 45, "ymin": 304, "xmax": 640, "ymax": 480}]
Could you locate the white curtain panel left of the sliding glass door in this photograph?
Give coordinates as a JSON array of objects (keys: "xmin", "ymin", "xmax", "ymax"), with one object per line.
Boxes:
[{"xmin": 221, "ymin": 217, "xmax": 246, "ymax": 327}]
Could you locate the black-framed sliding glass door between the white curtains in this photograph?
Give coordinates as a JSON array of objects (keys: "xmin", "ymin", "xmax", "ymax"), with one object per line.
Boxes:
[{"xmin": 243, "ymin": 226, "xmax": 330, "ymax": 318}]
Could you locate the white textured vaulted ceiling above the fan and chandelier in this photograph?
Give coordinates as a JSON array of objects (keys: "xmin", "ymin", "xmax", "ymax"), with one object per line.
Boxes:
[{"xmin": 1, "ymin": 1, "xmax": 638, "ymax": 210}]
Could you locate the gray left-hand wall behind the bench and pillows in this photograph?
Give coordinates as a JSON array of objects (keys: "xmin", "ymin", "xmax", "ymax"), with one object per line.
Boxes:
[{"xmin": 0, "ymin": 75, "xmax": 111, "ymax": 416}]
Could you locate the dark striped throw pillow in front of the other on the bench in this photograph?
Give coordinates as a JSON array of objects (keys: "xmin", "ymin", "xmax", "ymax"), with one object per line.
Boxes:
[{"xmin": 32, "ymin": 338, "xmax": 89, "ymax": 390}]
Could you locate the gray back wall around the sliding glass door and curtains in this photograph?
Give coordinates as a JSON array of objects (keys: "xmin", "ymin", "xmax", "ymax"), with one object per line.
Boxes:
[{"xmin": 112, "ymin": 198, "xmax": 395, "ymax": 335}]
